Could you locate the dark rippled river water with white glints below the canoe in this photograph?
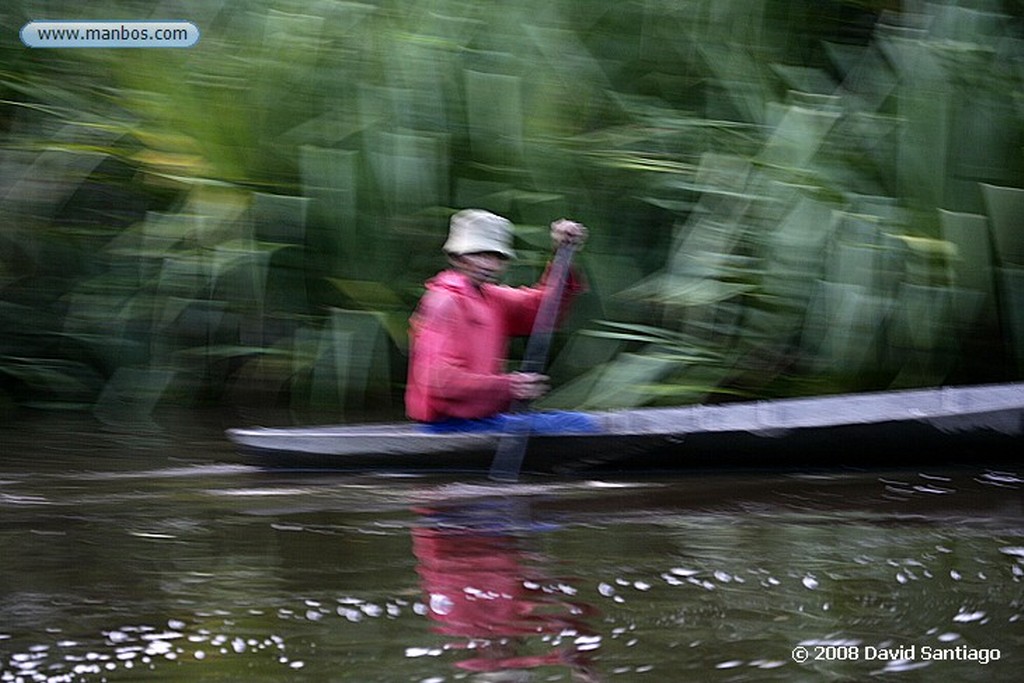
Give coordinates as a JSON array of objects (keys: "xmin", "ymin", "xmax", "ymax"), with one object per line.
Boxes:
[{"xmin": 0, "ymin": 413, "xmax": 1024, "ymax": 683}]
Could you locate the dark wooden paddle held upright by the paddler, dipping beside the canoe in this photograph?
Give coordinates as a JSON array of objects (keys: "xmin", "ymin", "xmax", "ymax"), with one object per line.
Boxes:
[{"xmin": 489, "ymin": 244, "xmax": 575, "ymax": 482}]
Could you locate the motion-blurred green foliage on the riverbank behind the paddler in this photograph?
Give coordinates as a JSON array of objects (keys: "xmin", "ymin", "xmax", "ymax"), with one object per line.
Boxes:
[{"xmin": 0, "ymin": 0, "xmax": 1024, "ymax": 424}]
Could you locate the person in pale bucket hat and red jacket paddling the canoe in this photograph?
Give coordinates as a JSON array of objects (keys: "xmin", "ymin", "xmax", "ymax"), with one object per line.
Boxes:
[{"xmin": 406, "ymin": 209, "xmax": 587, "ymax": 430}]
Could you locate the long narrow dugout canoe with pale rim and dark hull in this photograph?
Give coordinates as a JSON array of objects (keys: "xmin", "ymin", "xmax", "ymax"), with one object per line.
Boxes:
[{"xmin": 227, "ymin": 383, "xmax": 1024, "ymax": 474}]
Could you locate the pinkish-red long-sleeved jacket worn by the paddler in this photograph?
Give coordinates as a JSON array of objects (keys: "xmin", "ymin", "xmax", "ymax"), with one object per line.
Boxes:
[{"xmin": 406, "ymin": 270, "xmax": 585, "ymax": 422}]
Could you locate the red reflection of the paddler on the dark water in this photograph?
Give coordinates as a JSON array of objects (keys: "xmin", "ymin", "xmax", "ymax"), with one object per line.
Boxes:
[{"xmin": 413, "ymin": 503, "xmax": 596, "ymax": 680}]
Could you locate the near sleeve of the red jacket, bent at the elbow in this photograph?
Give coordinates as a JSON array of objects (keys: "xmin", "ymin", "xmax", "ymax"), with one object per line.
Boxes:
[{"xmin": 412, "ymin": 293, "xmax": 512, "ymax": 418}]
